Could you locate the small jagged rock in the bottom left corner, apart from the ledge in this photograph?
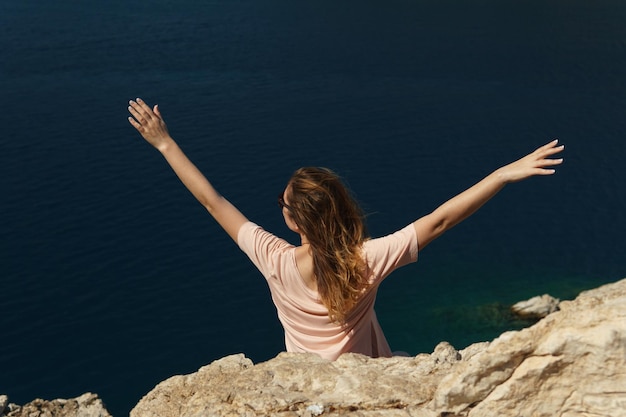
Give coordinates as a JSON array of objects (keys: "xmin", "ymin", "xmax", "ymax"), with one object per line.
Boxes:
[{"xmin": 0, "ymin": 393, "xmax": 111, "ymax": 417}]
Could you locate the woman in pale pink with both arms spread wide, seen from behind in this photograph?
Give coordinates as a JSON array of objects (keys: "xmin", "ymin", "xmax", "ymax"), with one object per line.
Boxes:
[{"xmin": 128, "ymin": 99, "xmax": 564, "ymax": 360}]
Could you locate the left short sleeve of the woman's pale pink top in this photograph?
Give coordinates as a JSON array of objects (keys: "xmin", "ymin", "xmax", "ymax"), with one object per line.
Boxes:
[{"xmin": 237, "ymin": 222, "xmax": 293, "ymax": 279}]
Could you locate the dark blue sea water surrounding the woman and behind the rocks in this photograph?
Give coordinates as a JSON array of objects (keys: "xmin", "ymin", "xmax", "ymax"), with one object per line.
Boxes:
[{"xmin": 0, "ymin": 0, "xmax": 626, "ymax": 416}]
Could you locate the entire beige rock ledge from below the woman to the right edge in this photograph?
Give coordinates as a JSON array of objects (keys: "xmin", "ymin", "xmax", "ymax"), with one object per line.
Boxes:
[{"xmin": 131, "ymin": 280, "xmax": 626, "ymax": 417}]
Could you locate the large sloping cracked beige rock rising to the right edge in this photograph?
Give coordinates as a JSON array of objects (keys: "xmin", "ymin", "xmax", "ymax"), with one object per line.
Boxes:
[{"xmin": 430, "ymin": 280, "xmax": 626, "ymax": 417}]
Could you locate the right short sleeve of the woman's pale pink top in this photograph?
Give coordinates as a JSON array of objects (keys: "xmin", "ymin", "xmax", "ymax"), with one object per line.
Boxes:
[{"xmin": 364, "ymin": 223, "xmax": 418, "ymax": 284}]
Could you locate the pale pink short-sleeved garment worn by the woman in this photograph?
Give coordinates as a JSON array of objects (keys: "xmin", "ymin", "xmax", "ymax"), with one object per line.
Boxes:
[{"xmin": 237, "ymin": 222, "xmax": 418, "ymax": 360}]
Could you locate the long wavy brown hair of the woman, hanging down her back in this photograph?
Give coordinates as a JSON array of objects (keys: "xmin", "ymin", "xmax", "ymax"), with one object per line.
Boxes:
[{"xmin": 287, "ymin": 167, "xmax": 367, "ymax": 323}]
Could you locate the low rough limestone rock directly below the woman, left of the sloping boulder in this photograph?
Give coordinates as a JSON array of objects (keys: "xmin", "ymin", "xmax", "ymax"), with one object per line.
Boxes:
[{"xmin": 130, "ymin": 343, "xmax": 472, "ymax": 417}]
